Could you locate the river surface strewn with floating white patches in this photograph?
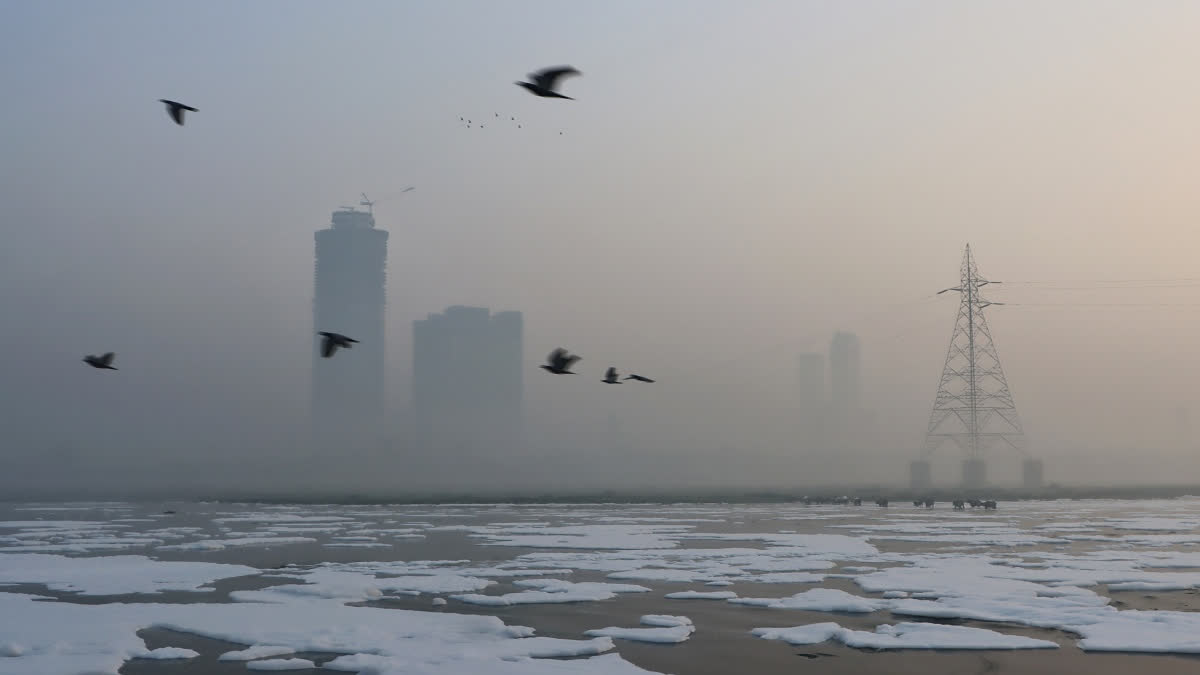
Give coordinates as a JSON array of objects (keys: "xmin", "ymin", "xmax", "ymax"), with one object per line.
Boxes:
[{"xmin": 0, "ymin": 498, "xmax": 1200, "ymax": 675}]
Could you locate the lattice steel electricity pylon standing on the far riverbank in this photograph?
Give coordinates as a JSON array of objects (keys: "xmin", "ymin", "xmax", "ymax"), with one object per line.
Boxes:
[{"xmin": 923, "ymin": 244, "xmax": 1027, "ymax": 486}]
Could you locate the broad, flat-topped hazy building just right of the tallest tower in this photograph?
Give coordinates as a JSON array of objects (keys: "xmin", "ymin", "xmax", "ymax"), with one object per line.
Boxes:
[{"xmin": 413, "ymin": 306, "xmax": 524, "ymax": 459}]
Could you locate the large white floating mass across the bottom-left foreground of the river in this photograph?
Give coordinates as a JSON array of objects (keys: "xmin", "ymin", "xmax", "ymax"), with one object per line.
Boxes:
[{"xmin": 0, "ymin": 593, "xmax": 641, "ymax": 675}]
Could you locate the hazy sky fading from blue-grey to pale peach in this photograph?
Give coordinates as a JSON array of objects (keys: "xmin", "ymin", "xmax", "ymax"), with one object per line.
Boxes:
[{"xmin": 0, "ymin": 0, "xmax": 1200, "ymax": 494}]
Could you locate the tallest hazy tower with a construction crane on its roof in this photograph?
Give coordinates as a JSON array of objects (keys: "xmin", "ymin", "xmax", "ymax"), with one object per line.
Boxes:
[{"xmin": 312, "ymin": 208, "xmax": 388, "ymax": 453}]
